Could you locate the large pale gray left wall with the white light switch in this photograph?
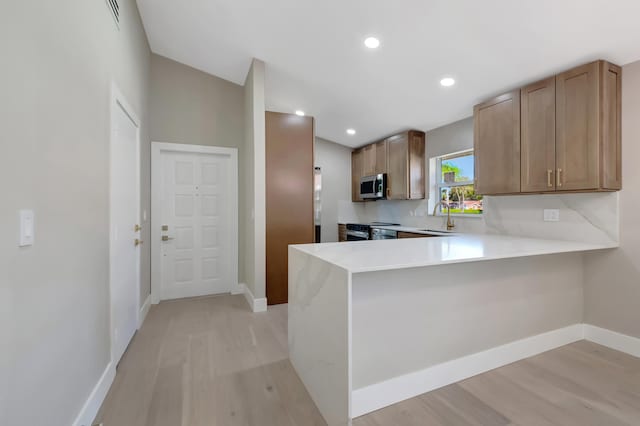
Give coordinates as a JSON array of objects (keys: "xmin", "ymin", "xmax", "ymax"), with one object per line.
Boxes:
[{"xmin": 0, "ymin": 0, "xmax": 150, "ymax": 426}]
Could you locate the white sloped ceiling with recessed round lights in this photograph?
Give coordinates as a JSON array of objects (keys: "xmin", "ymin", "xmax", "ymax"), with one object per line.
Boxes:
[{"xmin": 138, "ymin": 0, "xmax": 640, "ymax": 147}]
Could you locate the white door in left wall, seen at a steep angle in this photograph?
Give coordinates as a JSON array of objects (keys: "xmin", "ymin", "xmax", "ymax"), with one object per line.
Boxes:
[{"xmin": 109, "ymin": 99, "xmax": 140, "ymax": 363}]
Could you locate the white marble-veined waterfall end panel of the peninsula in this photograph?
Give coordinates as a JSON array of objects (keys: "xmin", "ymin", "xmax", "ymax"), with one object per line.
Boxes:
[{"xmin": 288, "ymin": 246, "xmax": 351, "ymax": 426}]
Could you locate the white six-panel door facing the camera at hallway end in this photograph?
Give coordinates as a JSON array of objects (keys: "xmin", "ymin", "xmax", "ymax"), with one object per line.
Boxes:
[{"xmin": 160, "ymin": 152, "xmax": 232, "ymax": 300}]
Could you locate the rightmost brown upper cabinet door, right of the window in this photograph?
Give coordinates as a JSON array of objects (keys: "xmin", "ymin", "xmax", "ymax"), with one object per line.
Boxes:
[{"xmin": 556, "ymin": 62, "xmax": 600, "ymax": 191}]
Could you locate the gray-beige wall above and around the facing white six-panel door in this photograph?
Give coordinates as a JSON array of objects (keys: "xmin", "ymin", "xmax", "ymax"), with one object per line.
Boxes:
[{"xmin": 149, "ymin": 54, "xmax": 246, "ymax": 286}]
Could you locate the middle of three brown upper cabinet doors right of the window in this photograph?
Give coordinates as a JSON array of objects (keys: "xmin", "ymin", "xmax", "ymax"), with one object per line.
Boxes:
[{"xmin": 520, "ymin": 77, "xmax": 556, "ymax": 192}]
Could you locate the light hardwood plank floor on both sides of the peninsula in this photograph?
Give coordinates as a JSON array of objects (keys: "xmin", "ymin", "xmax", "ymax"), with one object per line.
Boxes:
[{"xmin": 96, "ymin": 296, "xmax": 640, "ymax": 426}]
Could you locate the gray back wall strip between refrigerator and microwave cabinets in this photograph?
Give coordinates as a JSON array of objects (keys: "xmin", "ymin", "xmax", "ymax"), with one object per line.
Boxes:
[{"xmin": 314, "ymin": 138, "xmax": 351, "ymax": 243}]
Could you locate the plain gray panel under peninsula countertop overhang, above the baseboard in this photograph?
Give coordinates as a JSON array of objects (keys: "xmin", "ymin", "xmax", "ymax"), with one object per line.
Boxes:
[{"xmin": 352, "ymin": 253, "xmax": 583, "ymax": 390}]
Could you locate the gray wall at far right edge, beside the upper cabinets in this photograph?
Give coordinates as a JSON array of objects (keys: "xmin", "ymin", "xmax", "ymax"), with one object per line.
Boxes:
[{"xmin": 585, "ymin": 61, "xmax": 640, "ymax": 338}]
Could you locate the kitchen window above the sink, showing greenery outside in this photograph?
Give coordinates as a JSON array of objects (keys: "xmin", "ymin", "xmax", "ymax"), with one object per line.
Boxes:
[{"xmin": 436, "ymin": 150, "xmax": 482, "ymax": 215}]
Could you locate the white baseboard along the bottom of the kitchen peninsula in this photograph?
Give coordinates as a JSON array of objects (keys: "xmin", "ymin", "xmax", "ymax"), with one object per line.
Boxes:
[{"xmin": 351, "ymin": 324, "xmax": 584, "ymax": 417}]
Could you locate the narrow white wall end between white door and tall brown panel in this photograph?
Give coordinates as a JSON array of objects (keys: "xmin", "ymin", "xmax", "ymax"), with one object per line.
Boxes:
[{"xmin": 240, "ymin": 59, "xmax": 266, "ymax": 298}]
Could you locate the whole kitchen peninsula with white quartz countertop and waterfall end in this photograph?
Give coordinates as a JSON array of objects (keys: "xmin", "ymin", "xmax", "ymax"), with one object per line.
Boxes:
[{"xmin": 288, "ymin": 235, "xmax": 617, "ymax": 426}]
